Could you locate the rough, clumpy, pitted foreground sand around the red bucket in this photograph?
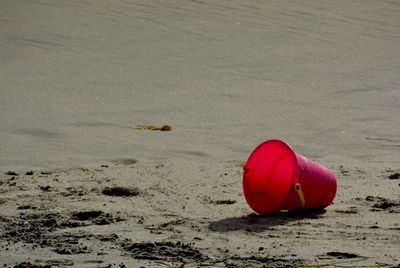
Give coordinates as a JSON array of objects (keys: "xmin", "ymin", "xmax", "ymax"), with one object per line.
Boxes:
[{"xmin": 0, "ymin": 161, "xmax": 400, "ymax": 267}]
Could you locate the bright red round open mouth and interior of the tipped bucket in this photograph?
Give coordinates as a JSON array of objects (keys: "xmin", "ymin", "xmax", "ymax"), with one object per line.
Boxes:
[{"xmin": 243, "ymin": 140, "xmax": 298, "ymax": 214}]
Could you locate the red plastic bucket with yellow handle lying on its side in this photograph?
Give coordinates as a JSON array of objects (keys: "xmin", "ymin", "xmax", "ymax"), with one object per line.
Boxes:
[{"xmin": 243, "ymin": 139, "xmax": 337, "ymax": 215}]
